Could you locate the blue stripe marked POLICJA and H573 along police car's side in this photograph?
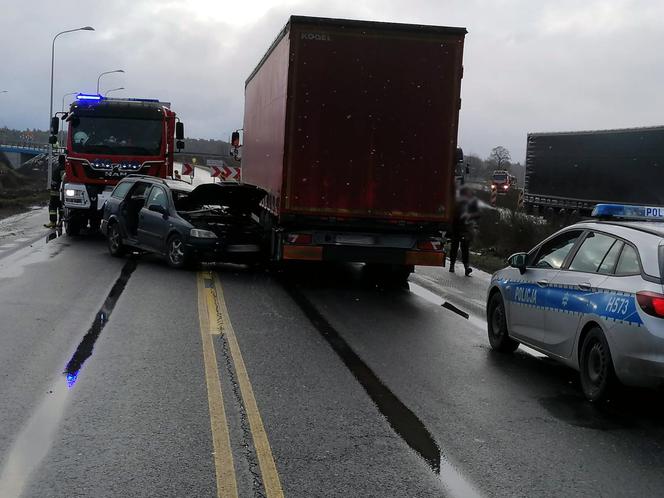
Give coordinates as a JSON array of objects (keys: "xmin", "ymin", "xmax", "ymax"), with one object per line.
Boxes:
[{"xmin": 499, "ymin": 280, "xmax": 643, "ymax": 325}]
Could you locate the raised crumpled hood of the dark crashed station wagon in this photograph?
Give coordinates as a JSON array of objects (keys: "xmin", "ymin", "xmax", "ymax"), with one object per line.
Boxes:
[{"xmin": 188, "ymin": 182, "xmax": 267, "ymax": 212}]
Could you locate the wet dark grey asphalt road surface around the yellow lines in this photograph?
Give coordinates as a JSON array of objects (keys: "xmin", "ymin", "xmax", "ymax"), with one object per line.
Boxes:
[{"xmin": 0, "ymin": 209, "xmax": 664, "ymax": 498}]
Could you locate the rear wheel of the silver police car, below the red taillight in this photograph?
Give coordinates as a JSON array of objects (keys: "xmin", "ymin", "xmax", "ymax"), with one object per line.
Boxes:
[{"xmin": 579, "ymin": 327, "xmax": 617, "ymax": 402}]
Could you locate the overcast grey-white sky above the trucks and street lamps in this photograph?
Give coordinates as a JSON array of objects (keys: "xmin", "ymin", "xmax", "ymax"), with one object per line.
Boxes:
[{"xmin": 0, "ymin": 0, "xmax": 664, "ymax": 162}]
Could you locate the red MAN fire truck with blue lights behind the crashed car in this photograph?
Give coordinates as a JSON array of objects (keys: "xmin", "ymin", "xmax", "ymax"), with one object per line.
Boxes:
[{"xmin": 52, "ymin": 94, "xmax": 184, "ymax": 235}]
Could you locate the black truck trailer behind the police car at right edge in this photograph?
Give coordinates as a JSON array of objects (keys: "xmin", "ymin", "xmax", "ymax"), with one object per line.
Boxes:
[{"xmin": 524, "ymin": 126, "xmax": 664, "ymax": 214}]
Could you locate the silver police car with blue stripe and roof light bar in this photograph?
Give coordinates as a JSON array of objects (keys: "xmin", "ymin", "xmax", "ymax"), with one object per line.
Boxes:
[{"xmin": 487, "ymin": 204, "xmax": 664, "ymax": 401}]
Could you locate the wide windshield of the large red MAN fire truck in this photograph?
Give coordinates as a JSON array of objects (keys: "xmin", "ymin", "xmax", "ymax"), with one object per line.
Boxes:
[{"xmin": 70, "ymin": 116, "xmax": 163, "ymax": 156}]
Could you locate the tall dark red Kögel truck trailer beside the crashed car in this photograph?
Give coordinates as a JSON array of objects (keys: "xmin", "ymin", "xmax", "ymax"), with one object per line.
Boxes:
[{"xmin": 242, "ymin": 17, "xmax": 466, "ymax": 271}]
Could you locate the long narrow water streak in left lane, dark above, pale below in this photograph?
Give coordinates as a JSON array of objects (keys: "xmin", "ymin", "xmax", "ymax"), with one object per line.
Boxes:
[{"xmin": 0, "ymin": 260, "xmax": 137, "ymax": 498}]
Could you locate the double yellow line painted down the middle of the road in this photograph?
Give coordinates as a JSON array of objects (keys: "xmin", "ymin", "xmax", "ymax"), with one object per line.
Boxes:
[{"xmin": 197, "ymin": 271, "xmax": 284, "ymax": 498}]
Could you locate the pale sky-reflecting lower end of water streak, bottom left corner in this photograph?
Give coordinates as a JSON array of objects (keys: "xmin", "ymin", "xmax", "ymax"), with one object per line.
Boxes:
[{"xmin": 0, "ymin": 377, "xmax": 69, "ymax": 498}]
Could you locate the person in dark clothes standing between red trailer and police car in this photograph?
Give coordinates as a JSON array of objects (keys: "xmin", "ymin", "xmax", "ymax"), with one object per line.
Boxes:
[{"xmin": 450, "ymin": 185, "xmax": 480, "ymax": 276}]
